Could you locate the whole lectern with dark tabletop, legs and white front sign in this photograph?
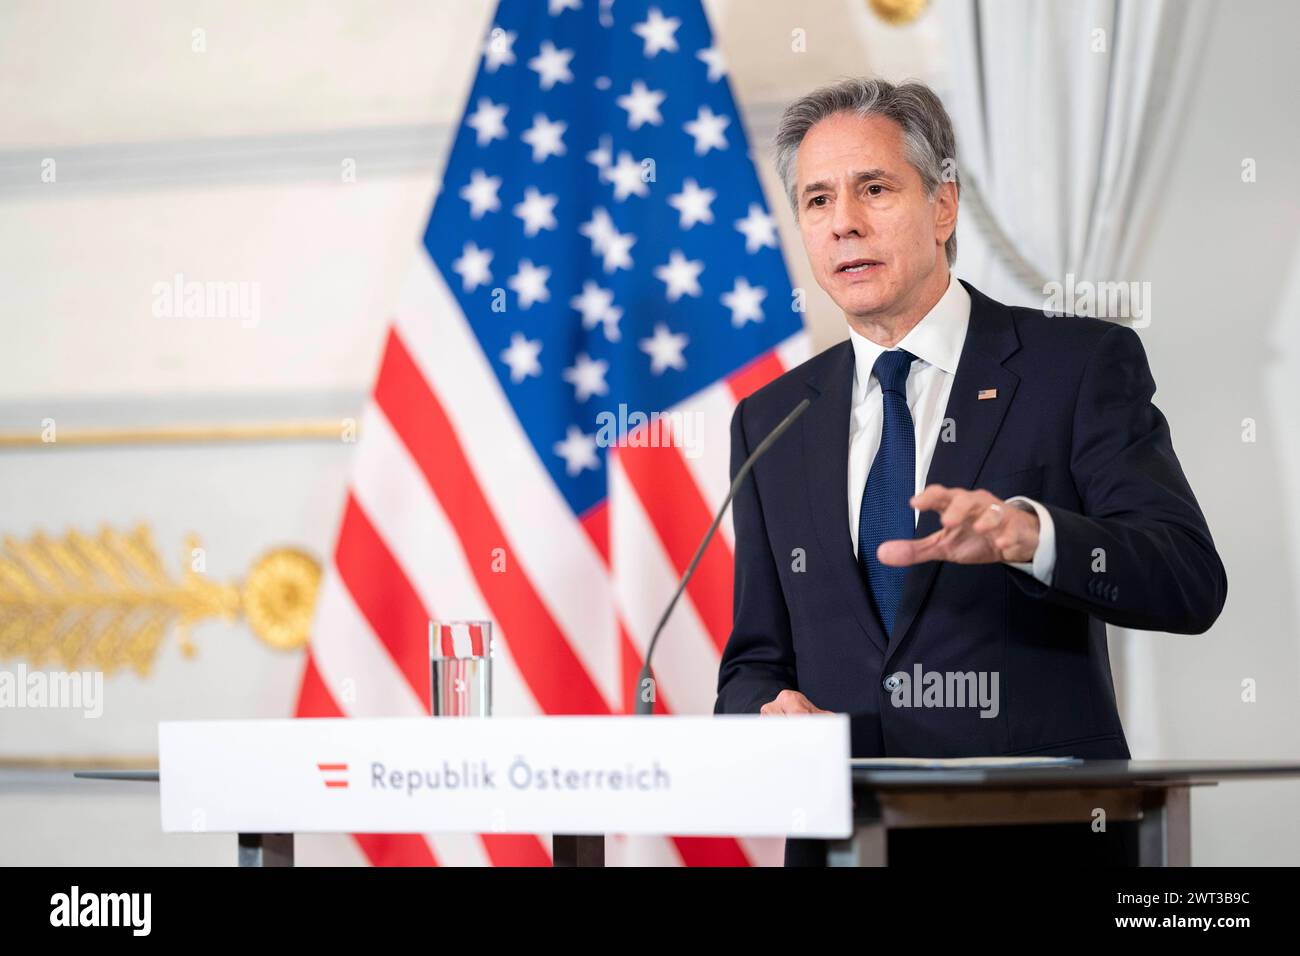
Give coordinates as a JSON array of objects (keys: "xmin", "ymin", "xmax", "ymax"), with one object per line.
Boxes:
[{"xmin": 75, "ymin": 715, "xmax": 1300, "ymax": 866}]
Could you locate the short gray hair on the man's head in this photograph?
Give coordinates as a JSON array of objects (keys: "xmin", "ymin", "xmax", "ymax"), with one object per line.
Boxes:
[{"xmin": 775, "ymin": 78, "xmax": 961, "ymax": 267}]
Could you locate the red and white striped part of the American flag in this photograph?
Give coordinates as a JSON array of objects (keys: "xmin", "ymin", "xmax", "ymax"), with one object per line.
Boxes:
[{"xmin": 296, "ymin": 248, "xmax": 807, "ymax": 865}]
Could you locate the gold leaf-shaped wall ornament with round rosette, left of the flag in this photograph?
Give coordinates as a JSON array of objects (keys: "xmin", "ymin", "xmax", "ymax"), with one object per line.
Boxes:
[{"xmin": 0, "ymin": 524, "xmax": 321, "ymax": 676}]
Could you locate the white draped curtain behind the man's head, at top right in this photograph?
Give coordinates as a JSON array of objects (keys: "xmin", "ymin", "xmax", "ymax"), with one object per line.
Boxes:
[{"xmin": 939, "ymin": 0, "xmax": 1212, "ymax": 304}]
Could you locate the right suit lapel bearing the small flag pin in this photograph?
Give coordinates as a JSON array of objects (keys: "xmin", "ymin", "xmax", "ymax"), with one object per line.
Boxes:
[{"xmin": 883, "ymin": 282, "xmax": 1021, "ymax": 666}]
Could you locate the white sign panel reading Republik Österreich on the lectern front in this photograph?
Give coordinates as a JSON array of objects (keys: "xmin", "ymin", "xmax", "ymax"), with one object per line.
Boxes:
[{"xmin": 159, "ymin": 714, "xmax": 852, "ymax": 838}]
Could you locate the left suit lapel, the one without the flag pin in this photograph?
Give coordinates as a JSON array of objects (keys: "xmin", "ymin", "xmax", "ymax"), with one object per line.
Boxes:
[{"xmin": 801, "ymin": 342, "xmax": 885, "ymax": 654}]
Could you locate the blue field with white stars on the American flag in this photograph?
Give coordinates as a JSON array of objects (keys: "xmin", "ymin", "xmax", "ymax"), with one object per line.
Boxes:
[{"xmin": 425, "ymin": 0, "xmax": 801, "ymax": 514}]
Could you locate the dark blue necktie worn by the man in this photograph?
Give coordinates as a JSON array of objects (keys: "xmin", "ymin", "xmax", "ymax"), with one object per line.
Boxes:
[{"xmin": 858, "ymin": 349, "xmax": 917, "ymax": 640}]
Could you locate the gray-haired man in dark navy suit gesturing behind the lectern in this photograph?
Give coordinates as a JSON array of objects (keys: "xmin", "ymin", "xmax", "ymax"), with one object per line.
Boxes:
[{"xmin": 715, "ymin": 81, "xmax": 1227, "ymax": 864}]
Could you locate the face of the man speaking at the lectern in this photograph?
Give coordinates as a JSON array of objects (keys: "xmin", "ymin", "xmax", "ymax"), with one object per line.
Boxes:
[{"xmin": 796, "ymin": 113, "xmax": 957, "ymax": 320}]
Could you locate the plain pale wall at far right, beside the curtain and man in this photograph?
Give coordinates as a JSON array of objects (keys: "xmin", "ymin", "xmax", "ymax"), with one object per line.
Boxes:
[{"xmin": 1113, "ymin": 3, "xmax": 1300, "ymax": 865}]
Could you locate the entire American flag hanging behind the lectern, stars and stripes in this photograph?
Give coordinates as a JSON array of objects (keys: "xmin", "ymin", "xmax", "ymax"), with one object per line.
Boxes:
[{"xmin": 296, "ymin": 0, "xmax": 807, "ymax": 865}]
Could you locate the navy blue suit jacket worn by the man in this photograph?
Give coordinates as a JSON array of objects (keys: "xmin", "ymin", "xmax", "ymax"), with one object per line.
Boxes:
[{"xmin": 714, "ymin": 282, "xmax": 1227, "ymax": 758}]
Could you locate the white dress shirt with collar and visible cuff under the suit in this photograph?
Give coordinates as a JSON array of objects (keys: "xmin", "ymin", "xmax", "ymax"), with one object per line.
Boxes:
[{"xmin": 849, "ymin": 276, "xmax": 1056, "ymax": 585}]
